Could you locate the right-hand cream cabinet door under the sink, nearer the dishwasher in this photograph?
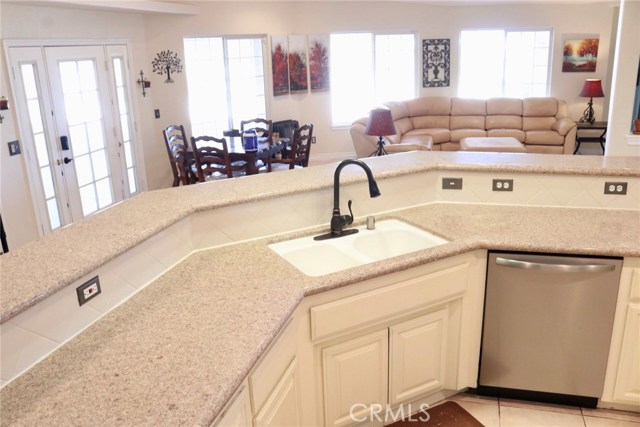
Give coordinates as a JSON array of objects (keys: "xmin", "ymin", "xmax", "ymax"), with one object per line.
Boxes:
[{"xmin": 389, "ymin": 305, "xmax": 449, "ymax": 405}]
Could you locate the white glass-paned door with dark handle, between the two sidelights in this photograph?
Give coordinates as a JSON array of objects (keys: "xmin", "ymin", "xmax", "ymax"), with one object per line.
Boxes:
[{"xmin": 45, "ymin": 46, "xmax": 123, "ymax": 220}]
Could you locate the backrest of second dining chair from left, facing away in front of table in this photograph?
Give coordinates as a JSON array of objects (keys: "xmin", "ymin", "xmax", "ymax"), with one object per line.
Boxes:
[{"xmin": 191, "ymin": 135, "xmax": 233, "ymax": 182}]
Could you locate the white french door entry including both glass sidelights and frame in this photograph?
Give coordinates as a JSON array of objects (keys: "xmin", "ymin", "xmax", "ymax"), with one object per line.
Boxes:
[{"xmin": 9, "ymin": 45, "xmax": 139, "ymax": 234}]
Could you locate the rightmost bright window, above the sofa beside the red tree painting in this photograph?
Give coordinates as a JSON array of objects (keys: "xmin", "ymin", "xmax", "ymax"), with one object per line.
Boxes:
[{"xmin": 458, "ymin": 30, "xmax": 551, "ymax": 98}]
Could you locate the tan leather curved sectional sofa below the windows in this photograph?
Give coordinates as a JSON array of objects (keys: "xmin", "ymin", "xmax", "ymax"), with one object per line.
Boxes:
[{"xmin": 351, "ymin": 96, "xmax": 576, "ymax": 157}]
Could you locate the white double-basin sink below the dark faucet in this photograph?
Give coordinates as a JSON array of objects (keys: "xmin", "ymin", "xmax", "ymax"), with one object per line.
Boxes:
[{"xmin": 269, "ymin": 219, "xmax": 448, "ymax": 277}]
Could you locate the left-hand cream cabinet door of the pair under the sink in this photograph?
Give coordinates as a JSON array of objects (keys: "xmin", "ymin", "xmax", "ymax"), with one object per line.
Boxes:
[{"xmin": 322, "ymin": 328, "xmax": 389, "ymax": 426}]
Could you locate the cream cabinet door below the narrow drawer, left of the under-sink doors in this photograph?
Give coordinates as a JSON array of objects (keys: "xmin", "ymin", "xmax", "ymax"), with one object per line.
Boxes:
[{"xmin": 255, "ymin": 359, "xmax": 300, "ymax": 427}]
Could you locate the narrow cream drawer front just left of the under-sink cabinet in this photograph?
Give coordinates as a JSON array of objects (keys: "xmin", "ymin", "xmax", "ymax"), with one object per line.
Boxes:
[{"xmin": 249, "ymin": 321, "xmax": 296, "ymax": 413}]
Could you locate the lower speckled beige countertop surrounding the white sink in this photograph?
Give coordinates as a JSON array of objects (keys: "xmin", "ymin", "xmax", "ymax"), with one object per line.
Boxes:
[{"xmin": 0, "ymin": 204, "xmax": 640, "ymax": 426}]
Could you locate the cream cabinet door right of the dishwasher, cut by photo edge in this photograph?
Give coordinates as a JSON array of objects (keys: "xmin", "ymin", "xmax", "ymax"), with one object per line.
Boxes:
[{"xmin": 613, "ymin": 300, "xmax": 640, "ymax": 405}]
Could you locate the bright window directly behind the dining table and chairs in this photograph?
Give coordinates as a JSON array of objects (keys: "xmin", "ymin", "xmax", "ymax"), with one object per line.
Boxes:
[{"xmin": 184, "ymin": 37, "xmax": 267, "ymax": 137}]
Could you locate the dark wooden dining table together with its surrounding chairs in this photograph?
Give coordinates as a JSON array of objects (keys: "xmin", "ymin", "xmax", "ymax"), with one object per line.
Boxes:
[{"xmin": 162, "ymin": 117, "xmax": 314, "ymax": 187}]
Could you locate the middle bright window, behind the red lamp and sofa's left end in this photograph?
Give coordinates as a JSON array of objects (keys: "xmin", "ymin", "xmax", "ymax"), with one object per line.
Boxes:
[{"xmin": 330, "ymin": 33, "xmax": 416, "ymax": 126}]
